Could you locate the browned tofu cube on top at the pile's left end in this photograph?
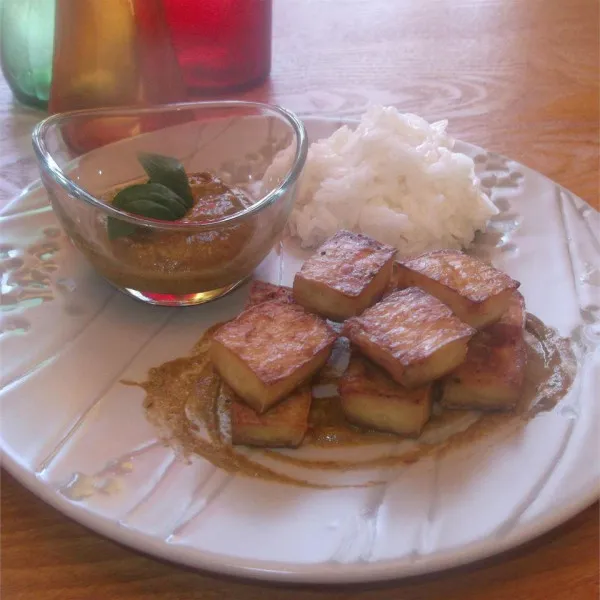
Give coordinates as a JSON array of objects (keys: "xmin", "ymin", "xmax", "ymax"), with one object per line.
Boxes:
[{"xmin": 210, "ymin": 301, "xmax": 337, "ymax": 413}]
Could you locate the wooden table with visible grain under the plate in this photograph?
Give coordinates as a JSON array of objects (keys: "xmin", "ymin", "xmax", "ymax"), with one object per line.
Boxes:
[{"xmin": 0, "ymin": 0, "xmax": 599, "ymax": 600}]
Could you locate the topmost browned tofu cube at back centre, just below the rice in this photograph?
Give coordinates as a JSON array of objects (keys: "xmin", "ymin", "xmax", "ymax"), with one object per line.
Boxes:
[{"xmin": 294, "ymin": 231, "xmax": 396, "ymax": 321}]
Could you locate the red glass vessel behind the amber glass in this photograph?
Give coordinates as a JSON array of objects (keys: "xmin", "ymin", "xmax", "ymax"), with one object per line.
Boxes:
[{"xmin": 163, "ymin": 0, "xmax": 272, "ymax": 93}]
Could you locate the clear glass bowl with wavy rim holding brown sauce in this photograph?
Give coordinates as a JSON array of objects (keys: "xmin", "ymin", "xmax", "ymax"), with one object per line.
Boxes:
[{"xmin": 33, "ymin": 101, "xmax": 307, "ymax": 306}]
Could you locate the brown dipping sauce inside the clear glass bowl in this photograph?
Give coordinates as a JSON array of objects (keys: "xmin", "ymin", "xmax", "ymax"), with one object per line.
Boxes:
[{"xmin": 62, "ymin": 173, "xmax": 278, "ymax": 295}]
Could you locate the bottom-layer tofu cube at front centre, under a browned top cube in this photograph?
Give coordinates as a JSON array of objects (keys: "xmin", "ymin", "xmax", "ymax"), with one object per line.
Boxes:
[{"xmin": 339, "ymin": 353, "xmax": 432, "ymax": 436}]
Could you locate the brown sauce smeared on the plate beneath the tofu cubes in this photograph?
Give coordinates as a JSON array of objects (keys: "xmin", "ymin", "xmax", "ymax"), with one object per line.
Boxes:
[{"xmin": 137, "ymin": 315, "xmax": 576, "ymax": 488}]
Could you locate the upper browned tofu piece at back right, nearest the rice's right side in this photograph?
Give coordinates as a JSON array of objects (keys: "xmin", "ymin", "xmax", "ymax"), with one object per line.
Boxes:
[{"xmin": 398, "ymin": 250, "xmax": 520, "ymax": 329}]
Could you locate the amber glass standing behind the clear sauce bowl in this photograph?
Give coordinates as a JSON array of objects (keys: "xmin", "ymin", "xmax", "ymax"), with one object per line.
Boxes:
[{"xmin": 48, "ymin": 0, "xmax": 187, "ymax": 151}]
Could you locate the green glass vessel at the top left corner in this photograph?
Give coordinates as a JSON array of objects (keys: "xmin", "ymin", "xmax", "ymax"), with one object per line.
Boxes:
[{"xmin": 0, "ymin": 0, "xmax": 55, "ymax": 108}]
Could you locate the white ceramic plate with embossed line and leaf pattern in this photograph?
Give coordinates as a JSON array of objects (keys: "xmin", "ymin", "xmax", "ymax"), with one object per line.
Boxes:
[{"xmin": 0, "ymin": 119, "xmax": 600, "ymax": 582}]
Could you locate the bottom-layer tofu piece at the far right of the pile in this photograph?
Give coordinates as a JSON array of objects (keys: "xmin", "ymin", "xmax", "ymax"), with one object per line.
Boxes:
[{"xmin": 440, "ymin": 292, "xmax": 527, "ymax": 410}]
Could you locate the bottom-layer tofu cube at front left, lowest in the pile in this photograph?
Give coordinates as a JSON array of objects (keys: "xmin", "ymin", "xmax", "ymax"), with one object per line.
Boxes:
[{"xmin": 231, "ymin": 386, "xmax": 312, "ymax": 448}]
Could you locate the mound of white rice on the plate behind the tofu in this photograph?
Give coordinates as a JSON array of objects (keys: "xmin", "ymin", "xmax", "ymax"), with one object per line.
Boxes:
[{"xmin": 264, "ymin": 106, "xmax": 498, "ymax": 256}]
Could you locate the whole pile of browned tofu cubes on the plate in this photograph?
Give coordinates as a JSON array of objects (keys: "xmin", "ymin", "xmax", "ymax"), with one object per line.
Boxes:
[{"xmin": 211, "ymin": 231, "xmax": 526, "ymax": 447}]
